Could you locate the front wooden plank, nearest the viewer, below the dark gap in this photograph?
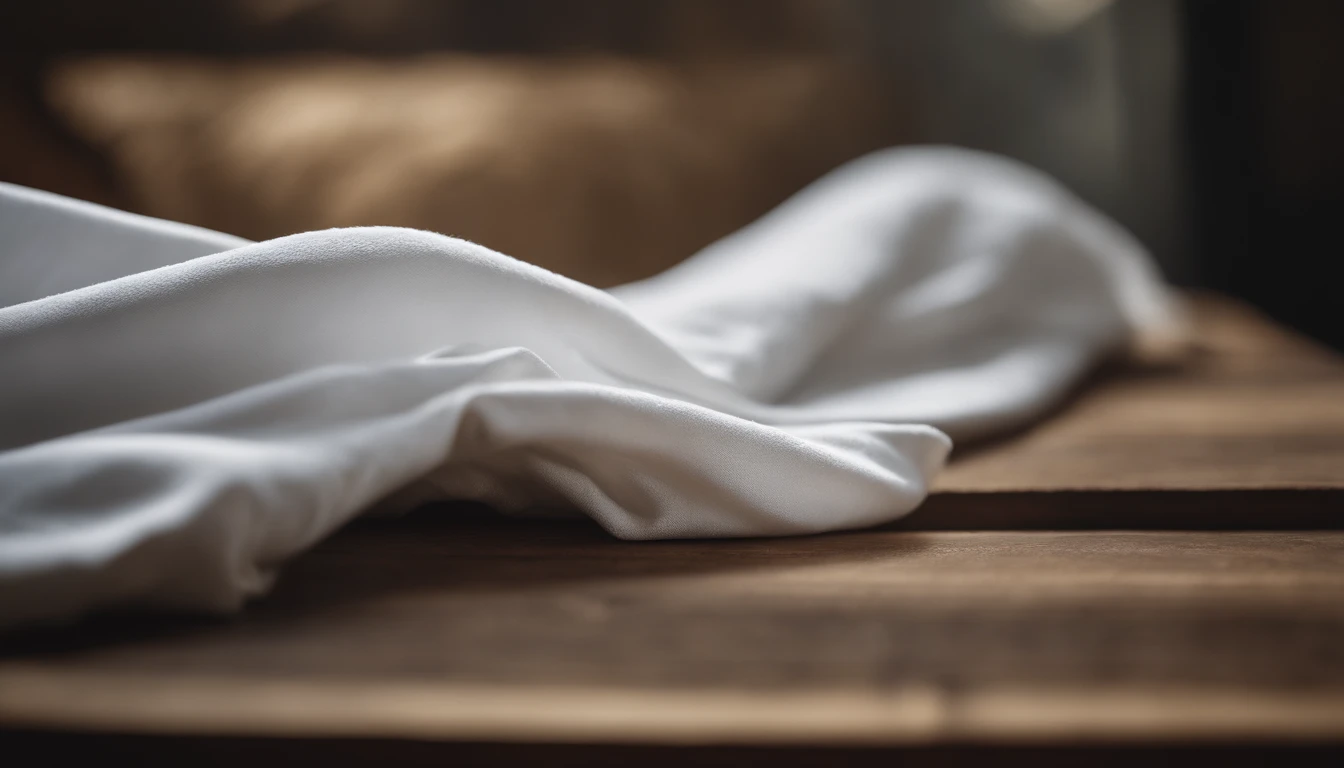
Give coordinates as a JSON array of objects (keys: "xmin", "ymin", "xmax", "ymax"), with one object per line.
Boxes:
[{"xmin": 0, "ymin": 521, "xmax": 1344, "ymax": 745}]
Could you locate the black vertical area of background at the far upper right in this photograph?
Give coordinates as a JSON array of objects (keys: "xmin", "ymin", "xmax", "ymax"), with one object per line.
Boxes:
[{"xmin": 1183, "ymin": 0, "xmax": 1344, "ymax": 348}]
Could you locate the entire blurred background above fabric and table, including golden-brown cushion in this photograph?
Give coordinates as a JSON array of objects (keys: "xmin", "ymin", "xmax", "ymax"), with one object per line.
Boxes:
[{"xmin": 0, "ymin": 0, "xmax": 1344, "ymax": 347}]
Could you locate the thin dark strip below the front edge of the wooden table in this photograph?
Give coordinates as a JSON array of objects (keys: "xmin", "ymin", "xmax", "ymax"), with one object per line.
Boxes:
[{"xmin": 4, "ymin": 732, "xmax": 1344, "ymax": 768}]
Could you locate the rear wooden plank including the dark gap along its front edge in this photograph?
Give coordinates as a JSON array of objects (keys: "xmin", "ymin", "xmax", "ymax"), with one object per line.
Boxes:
[{"xmin": 898, "ymin": 296, "xmax": 1344, "ymax": 530}]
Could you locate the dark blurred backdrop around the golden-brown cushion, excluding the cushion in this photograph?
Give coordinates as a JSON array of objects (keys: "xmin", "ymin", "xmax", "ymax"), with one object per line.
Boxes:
[{"xmin": 0, "ymin": 0, "xmax": 1344, "ymax": 348}]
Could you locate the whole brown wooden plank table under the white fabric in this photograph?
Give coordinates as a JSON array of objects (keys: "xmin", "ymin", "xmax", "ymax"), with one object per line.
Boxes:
[{"xmin": 0, "ymin": 299, "xmax": 1344, "ymax": 765}]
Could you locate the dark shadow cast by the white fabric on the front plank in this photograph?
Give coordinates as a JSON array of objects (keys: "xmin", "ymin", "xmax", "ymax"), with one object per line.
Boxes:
[{"xmin": 0, "ymin": 503, "xmax": 926, "ymax": 658}]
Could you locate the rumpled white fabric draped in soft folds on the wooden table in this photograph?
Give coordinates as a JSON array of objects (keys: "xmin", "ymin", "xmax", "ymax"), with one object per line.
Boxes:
[{"xmin": 0, "ymin": 149, "xmax": 1173, "ymax": 624}]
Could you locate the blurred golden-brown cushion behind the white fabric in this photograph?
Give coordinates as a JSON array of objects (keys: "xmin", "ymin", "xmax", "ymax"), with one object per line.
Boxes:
[{"xmin": 47, "ymin": 55, "xmax": 878, "ymax": 285}]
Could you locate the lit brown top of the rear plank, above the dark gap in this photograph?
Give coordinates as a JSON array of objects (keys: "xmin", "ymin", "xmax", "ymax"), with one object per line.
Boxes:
[{"xmin": 938, "ymin": 297, "xmax": 1344, "ymax": 492}]
